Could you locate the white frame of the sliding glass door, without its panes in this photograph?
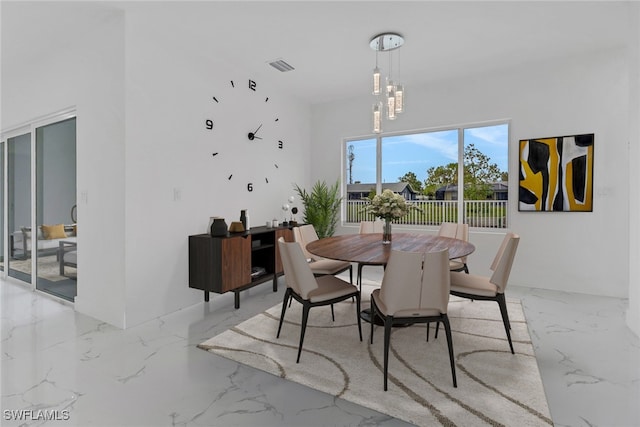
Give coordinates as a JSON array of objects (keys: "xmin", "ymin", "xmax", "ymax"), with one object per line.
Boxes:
[{"xmin": 0, "ymin": 107, "xmax": 77, "ymax": 304}]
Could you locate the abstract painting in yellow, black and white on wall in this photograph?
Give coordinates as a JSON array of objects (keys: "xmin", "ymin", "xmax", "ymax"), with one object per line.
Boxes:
[{"xmin": 518, "ymin": 133, "xmax": 594, "ymax": 212}]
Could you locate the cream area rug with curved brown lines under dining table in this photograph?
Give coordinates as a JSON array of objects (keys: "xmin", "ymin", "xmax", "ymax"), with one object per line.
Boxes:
[{"xmin": 199, "ymin": 285, "xmax": 553, "ymax": 426}]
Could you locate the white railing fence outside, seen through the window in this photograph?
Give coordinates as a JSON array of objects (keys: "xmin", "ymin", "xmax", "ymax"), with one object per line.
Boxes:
[{"xmin": 346, "ymin": 200, "xmax": 507, "ymax": 228}]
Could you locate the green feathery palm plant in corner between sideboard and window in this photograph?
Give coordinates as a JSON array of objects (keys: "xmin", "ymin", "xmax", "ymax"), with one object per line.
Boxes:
[{"xmin": 295, "ymin": 180, "xmax": 342, "ymax": 239}]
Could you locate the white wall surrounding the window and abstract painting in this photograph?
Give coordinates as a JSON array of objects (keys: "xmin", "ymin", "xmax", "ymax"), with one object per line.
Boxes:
[{"xmin": 311, "ymin": 49, "xmax": 629, "ymax": 297}]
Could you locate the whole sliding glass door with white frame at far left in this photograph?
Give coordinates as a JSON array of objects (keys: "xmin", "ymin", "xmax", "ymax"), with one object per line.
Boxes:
[{"xmin": 0, "ymin": 111, "xmax": 78, "ymax": 302}]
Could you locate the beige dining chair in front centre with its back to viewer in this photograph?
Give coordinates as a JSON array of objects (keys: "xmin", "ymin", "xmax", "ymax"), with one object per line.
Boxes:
[{"xmin": 371, "ymin": 249, "xmax": 458, "ymax": 391}]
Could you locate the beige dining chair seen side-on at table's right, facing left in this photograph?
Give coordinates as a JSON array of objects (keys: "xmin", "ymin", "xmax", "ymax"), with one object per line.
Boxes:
[{"xmin": 451, "ymin": 233, "xmax": 520, "ymax": 353}]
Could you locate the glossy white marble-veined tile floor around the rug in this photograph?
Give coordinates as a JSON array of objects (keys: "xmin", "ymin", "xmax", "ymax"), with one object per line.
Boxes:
[{"xmin": 0, "ymin": 269, "xmax": 640, "ymax": 426}]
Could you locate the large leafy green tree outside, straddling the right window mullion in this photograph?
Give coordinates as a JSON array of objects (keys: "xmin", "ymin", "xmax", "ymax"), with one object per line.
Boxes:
[{"xmin": 424, "ymin": 144, "xmax": 508, "ymax": 200}]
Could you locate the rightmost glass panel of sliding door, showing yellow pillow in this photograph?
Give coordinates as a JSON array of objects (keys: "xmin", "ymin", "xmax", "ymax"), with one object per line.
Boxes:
[{"xmin": 35, "ymin": 117, "xmax": 78, "ymax": 301}]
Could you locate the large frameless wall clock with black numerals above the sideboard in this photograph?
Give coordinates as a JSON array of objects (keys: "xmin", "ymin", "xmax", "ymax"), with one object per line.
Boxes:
[{"xmin": 202, "ymin": 79, "xmax": 285, "ymax": 192}]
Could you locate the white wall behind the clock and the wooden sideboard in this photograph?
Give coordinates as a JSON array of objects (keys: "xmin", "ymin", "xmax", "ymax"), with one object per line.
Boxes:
[{"xmin": 124, "ymin": 4, "xmax": 310, "ymax": 326}]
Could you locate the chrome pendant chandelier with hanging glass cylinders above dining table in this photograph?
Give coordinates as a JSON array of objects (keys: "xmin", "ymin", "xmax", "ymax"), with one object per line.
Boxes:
[{"xmin": 369, "ymin": 33, "xmax": 404, "ymax": 133}]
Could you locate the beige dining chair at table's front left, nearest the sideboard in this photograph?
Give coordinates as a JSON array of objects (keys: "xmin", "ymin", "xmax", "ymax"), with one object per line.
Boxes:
[{"xmin": 276, "ymin": 237, "xmax": 362, "ymax": 363}]
